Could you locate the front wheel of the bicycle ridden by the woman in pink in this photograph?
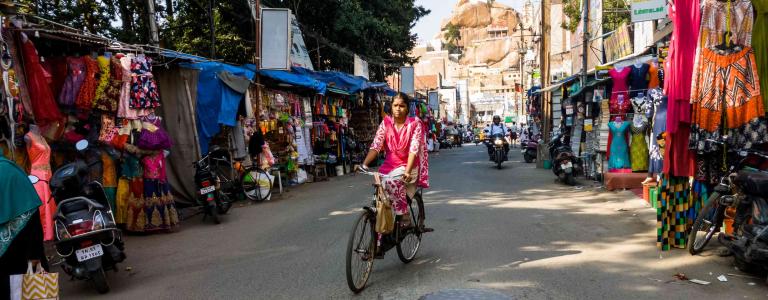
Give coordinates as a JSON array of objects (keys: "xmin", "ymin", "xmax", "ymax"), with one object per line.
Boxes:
[{"xmin": 347, "ymin": 212, "xmax": 376, "ymax": 293}]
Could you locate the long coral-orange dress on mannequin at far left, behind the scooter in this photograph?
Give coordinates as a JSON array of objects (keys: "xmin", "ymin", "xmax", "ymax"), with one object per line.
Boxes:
[{"xmin": 26, "ymin": 131, "xmax": 56, "ymax": 241}]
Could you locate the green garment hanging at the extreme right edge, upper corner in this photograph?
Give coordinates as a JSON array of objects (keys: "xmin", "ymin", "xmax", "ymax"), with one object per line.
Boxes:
[{"xmin": 752, "ymin": 0, "xmax": 768, "ymax": 111}]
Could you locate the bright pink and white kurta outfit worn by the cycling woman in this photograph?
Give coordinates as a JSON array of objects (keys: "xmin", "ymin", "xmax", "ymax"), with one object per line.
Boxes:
[{"xmin": 371, "ymin": 116, "xmax": 429, "ymax": 215}]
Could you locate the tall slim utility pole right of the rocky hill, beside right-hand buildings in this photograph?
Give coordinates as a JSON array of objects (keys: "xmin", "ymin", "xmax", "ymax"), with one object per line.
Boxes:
[{"xmin": 536, "ymin": 0, "xmax": 552, "ymax": 168}]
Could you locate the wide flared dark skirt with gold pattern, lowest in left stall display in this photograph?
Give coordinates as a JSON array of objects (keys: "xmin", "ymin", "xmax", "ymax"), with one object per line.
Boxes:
[{"xmin": 126, "ymin": 178, "xmax": 179, "ymax": 232}]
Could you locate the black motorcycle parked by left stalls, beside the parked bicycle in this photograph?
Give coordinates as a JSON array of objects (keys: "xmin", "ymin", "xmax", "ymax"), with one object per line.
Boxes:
[{"xmin": 194, "ymin": 146, "xmax": 231, "ymax": 224}]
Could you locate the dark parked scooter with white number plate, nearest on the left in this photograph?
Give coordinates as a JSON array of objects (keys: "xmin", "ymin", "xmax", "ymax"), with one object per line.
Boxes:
[{"xmin": 44, "ymin": 140, "xmax": 125, "ymax": 294}]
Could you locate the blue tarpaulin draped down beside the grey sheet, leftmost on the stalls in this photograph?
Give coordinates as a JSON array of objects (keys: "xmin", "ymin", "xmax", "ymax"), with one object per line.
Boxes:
[{"xmin": 181, "ymin": 62, "xmax": 255, "ymax": 153}]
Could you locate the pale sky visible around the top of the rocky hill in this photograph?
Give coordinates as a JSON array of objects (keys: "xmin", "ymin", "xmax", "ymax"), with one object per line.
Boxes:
[{"xmin": 411, "ymin": 0, "xmax": 524, "ymax": 40}]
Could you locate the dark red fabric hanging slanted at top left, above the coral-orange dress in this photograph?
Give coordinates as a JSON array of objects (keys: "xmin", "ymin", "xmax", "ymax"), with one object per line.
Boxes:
[{"xmin": 22, "ymin": 40, "xmax": 62, "ymax": 126}]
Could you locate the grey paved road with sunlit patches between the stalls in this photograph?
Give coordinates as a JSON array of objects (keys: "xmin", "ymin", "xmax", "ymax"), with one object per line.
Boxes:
[{"xmin": 61, "ymin": 146, "xmax": 768, "ymax": 299}]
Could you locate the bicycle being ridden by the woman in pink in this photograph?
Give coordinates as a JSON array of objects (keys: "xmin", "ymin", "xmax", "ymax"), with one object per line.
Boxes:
[{"xmin": 346, "ymin": 170, "xmax": 433, "ymax": 293}]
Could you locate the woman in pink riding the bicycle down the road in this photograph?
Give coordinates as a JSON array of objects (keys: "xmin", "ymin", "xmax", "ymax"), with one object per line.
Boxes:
[{"xmin": 363, "ymin": 93, "xmax": 429, "ymax": 225}]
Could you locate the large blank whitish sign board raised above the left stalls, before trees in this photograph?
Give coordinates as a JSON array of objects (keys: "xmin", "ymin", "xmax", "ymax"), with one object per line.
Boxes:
[{"xmin": 259, "ymin": 8, "xmax": 293, "ymax": 70}]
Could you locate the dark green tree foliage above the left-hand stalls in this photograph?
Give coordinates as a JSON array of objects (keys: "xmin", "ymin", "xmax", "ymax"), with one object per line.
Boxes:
[{"xmin": 19, "ymin": 0, "xmax": 429, "ymax": 80}]
